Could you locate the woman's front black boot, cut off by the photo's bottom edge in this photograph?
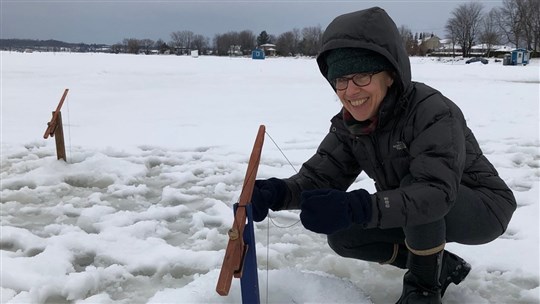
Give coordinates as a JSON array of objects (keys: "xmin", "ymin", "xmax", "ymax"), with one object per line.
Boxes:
[{"xmin": 396, "ymin": 251, "xmax": 443, "ymax": 304}]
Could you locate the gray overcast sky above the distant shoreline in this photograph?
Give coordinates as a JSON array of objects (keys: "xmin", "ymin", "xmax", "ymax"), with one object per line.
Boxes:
[{"xmin": 0, "ymin": 0, "xmax": 502, "ymax": 44}]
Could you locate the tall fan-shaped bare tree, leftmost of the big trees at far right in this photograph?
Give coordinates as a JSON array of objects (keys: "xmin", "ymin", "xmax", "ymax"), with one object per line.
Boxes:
[{"xmin": 446, "ymin": 2, "xmax": 483, "ymax": 57}]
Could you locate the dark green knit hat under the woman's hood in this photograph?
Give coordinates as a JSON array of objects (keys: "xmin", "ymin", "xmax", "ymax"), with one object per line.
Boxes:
[{"xmin": 326, "ymin": 48, "xmax": 394, "ymax": 81}]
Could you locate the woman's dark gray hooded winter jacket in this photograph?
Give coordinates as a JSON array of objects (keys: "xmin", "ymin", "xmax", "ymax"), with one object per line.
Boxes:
[{"xmin": 281, "ymin": 8, "xmax": 516, "ymax": 231}]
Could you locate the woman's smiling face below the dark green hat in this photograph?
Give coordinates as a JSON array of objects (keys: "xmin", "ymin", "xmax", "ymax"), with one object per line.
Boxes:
[{"xmin": 336, "ymin": 71, "xmax": 394, "ymax": 121}]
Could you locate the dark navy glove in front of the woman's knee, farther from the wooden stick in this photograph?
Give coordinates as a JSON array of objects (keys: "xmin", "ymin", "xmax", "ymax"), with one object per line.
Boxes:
[{"xmin": 300, "ymin": 189, "xmax": 371, "ymax": 234}]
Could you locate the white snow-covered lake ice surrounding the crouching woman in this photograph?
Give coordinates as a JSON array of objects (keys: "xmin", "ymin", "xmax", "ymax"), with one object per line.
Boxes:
[{"xmin": 0, "ymin": 52, "xmax": 540, "ymax": 304}]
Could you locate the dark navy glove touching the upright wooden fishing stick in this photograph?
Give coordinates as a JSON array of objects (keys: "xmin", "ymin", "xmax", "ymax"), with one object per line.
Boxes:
[{"xmin": 251, "ymin": 177, "xmax": 287, "ymax": 222}]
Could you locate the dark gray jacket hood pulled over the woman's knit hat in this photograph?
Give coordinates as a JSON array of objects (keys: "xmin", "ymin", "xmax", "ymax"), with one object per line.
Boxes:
[{"xmin": 317, "ymin": 7, "xmax": 411, "ymax": 94}]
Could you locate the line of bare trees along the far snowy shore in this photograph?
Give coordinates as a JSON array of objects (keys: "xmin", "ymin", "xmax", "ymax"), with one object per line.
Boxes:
[{"xmin": 2, "ymin": 0, "xmax": 540, "ymax": 57}]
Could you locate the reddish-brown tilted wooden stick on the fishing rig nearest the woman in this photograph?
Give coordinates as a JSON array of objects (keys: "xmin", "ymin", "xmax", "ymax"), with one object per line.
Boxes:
[{"xmin": 216, "ymin": 125, "xmax": 265, "ymax": 296}]
